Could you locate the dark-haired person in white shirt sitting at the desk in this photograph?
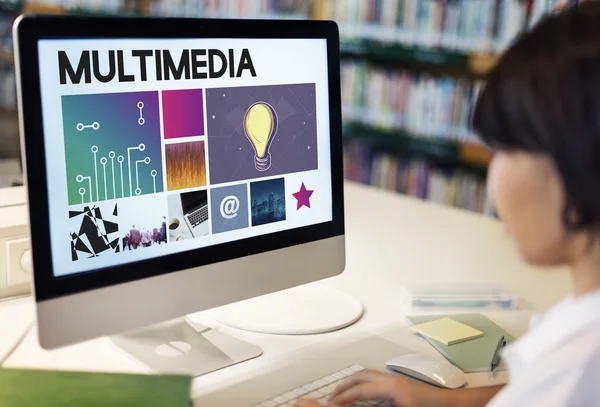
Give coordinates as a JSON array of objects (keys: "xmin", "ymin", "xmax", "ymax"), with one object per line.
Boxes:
[{"xmin": 296, "ymin": 0, "xmax": 600, "ymax": 407}]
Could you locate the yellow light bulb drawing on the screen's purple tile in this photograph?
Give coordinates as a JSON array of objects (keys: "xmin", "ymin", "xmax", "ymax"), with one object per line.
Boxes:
[{"xmin": 244, "ymin": 102, "xmax": 277, "ymax": 171}]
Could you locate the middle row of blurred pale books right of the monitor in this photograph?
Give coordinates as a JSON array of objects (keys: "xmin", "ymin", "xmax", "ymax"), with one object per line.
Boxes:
[{"xmin": 341, "ymin": 60, "xmax": 483, "ymax": 143}]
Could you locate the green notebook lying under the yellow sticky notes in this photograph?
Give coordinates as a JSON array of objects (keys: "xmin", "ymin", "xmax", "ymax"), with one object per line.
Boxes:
[{"xmin": 407, "ymin": 314, "xmax": 515, "ymax": 373}]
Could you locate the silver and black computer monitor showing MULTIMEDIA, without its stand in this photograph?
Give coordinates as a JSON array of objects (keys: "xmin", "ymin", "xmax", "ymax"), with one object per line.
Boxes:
[{"xmin": 14, "ymin": 16, "xmax": 345, "ymax": 372}]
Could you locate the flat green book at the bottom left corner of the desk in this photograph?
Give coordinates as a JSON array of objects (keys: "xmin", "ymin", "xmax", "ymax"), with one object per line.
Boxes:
[{"xmin": 0, "ymin": 369, "xmax": 192, "ymax": 407}]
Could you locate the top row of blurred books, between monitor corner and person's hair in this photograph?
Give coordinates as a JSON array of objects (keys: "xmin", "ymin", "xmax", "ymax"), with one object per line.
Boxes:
[{"xmin": 322, "ymin": 0, "xmax": 567, "ymax": 52}]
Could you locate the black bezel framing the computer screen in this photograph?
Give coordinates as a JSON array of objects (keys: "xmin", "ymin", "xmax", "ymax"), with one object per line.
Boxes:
[{"xmin": 15, "ymin": 15, "xmax": 344, "ymax": 302}]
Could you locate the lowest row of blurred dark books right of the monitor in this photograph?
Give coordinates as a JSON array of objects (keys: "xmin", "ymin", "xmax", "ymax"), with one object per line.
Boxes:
[{"xmin": 344, "ymin": 141, "xmax": 494, "ymax": 216}]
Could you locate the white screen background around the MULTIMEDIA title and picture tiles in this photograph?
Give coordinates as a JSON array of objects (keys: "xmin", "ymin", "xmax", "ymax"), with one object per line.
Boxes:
[{"xmin": 39, "ymin": 39, "xmax": 332, "ymax": 276}]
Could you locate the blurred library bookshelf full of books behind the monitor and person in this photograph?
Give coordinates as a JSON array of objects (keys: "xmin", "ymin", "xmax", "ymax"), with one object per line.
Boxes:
[{"xmin": 0, "ymin": 0, "xmax": 573, "ymax": 213}]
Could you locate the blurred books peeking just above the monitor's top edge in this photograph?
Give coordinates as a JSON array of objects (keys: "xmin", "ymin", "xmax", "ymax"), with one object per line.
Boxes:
[{"xmin": 150, "ymin": 0, "xmax": 311, "ymax": 19}]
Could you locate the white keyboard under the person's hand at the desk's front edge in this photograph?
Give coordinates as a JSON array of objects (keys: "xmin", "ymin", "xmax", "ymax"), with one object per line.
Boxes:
[{"xmin": 254, "ymin": 365, "xmax": 393, "ymax": 407}]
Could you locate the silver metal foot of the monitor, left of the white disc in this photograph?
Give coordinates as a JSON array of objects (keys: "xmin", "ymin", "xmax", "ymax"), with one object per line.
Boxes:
[{"xmin": 111, "ymin": 318, "xmax": 263, "ymax": 376}]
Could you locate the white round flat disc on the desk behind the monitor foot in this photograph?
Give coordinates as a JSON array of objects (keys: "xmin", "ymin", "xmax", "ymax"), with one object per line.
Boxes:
[{"xmin": 204, "ymin": 283, "xmax": 364, "ymax": 335}]
